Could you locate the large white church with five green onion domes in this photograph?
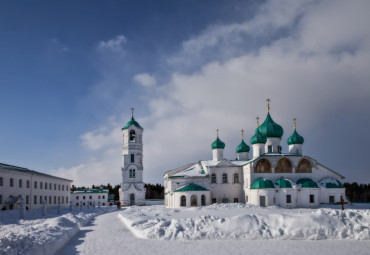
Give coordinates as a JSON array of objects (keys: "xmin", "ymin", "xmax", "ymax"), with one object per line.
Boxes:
[{"xmin": 164, "ymin": 99, "xmax": 345, "ymax": 208}]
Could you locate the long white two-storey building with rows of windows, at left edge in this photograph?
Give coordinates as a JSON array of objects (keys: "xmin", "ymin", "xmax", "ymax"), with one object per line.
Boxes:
[{"xmin": 0, "ymin": 163, "xmax": 72, "ymax": 210}]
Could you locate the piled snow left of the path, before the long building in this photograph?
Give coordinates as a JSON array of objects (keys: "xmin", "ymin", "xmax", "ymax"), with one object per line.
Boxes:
[{"xmin": 0, "ymin": 207, "xmax": 115, "ymax": 255}]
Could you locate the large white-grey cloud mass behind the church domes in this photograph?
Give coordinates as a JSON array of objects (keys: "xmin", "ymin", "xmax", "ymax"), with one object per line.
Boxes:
[{"xmin": 52, "ymin": 1, "xmax": 370, "ymax": 184}]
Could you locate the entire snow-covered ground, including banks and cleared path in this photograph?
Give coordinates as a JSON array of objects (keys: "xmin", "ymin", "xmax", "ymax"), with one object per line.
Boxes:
[{"xmin": 0, "ymin": 204, "xmax": 370, "ymax": 255}]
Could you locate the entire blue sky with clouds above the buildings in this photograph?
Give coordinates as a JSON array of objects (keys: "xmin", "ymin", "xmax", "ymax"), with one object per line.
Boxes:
[{"xmin": 0, "ymin": 0, "xmax": 370, "ymax": 185}]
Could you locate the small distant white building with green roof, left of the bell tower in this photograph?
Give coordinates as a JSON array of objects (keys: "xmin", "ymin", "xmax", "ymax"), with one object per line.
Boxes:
[{"xmin": 71, "ymin": 190, "xmax": 109, "ymax": 206}]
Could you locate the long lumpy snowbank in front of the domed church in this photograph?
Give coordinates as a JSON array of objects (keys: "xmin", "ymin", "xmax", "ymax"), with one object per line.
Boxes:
[{"xmin": 119, "ymin": 204, "xmax": 370, "ymax": 240}]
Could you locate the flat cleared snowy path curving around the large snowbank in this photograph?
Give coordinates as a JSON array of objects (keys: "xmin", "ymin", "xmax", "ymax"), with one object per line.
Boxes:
[{"xmin": 58, "ymin": 209, "xmax": 370, "ymax": 255}]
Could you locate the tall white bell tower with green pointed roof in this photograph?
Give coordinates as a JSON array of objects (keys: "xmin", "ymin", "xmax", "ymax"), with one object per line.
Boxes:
[{"xmin": 119, "ymin": 109, "xmax": 146, "ymax": 206}]
